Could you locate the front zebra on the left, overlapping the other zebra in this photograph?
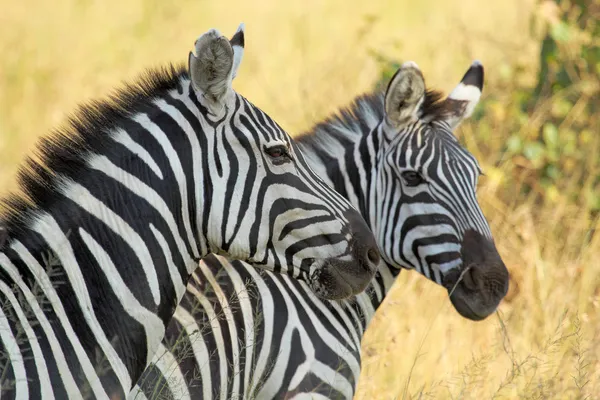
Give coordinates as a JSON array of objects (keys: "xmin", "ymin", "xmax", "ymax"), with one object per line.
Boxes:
[{"xmin": 0, "ymin": 25, "xmax": 379, "ymax": 399}]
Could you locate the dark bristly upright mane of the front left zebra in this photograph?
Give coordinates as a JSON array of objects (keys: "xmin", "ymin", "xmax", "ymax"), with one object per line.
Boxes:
[{"xmin": 0, "ymin": 65, "xmax": 187, "ymax": 234}]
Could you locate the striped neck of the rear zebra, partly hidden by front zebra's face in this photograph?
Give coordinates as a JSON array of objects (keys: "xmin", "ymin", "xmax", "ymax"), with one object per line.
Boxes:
[{"xmin": 296, "ymin": 92, "xmax": 400, "ymax": 327}]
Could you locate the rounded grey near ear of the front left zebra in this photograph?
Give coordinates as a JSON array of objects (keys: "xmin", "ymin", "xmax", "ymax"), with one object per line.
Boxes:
[{"xmin": 188, "ymin": 29, "xmax": 234, "ymax": 103}]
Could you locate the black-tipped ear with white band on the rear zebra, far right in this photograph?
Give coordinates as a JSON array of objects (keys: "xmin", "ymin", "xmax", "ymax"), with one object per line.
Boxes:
[{"xmin": 444, "ymin": 61, "xmax": 483, "ymax": 129}]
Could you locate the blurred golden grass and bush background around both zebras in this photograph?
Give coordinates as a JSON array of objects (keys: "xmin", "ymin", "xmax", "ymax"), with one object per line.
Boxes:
[{"xmin": 0, "ymin": 0, "xmax": 600, "ymax": 399}]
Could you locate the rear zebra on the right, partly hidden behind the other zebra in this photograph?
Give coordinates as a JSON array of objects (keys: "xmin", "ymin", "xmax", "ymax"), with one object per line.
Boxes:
[{"xmin": 129, "ymin": 62, "xmax": 509, "ymax": 400}]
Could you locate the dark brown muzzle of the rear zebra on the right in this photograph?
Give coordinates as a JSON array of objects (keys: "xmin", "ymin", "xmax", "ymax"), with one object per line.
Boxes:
[{"xmin": 442, "ymin": 231, "xmax": 509, "ymax": 321}]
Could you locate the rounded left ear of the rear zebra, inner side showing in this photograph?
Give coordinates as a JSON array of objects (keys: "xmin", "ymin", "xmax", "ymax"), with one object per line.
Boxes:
[{"xmin": 385, "ymin": 61, "xmax": 425, "ymax": 127}]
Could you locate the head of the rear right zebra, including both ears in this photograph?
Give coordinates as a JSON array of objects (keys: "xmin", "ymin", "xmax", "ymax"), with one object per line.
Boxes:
[{"xmin": 373, "ymin": 62, "xmax": 509, "ymax": 320}]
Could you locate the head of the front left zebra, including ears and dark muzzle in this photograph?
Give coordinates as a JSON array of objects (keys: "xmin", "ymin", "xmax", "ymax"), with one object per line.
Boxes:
[{"xmin": 189, "ymin": 25, "xmax": 380, "ymax": 299}]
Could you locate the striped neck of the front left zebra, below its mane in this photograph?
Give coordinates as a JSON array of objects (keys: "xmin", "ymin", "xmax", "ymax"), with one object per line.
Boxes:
[{"xmin": 0, "ymin": 74, "xmax": 216, "ymax": 397}]
